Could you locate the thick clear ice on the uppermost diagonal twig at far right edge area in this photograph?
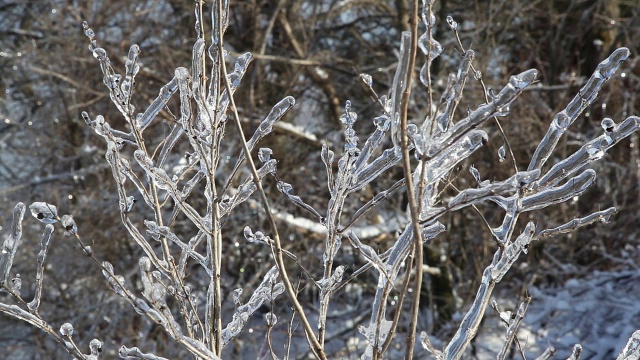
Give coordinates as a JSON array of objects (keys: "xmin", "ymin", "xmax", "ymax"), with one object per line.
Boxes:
[{"xmin": 528, "ymin": 47, "xmax": 629, "ymax": 170}]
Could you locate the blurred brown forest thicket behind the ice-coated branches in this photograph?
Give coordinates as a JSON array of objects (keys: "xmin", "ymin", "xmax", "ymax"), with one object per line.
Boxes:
[{"xmin": 0, "ymin": 0, "xmax": 640, "ymax": 359}]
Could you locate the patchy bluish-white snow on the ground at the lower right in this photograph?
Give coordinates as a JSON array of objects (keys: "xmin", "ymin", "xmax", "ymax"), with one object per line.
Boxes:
[{"xmin": 475, "ymin": 269, "xmax": 640, "ymax": 359}]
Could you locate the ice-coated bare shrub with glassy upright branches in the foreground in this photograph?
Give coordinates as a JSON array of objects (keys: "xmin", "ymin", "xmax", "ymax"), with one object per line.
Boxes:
[{"xmin": 0, "ymin": 1, "xmax": 640, "ymax": 359}]
